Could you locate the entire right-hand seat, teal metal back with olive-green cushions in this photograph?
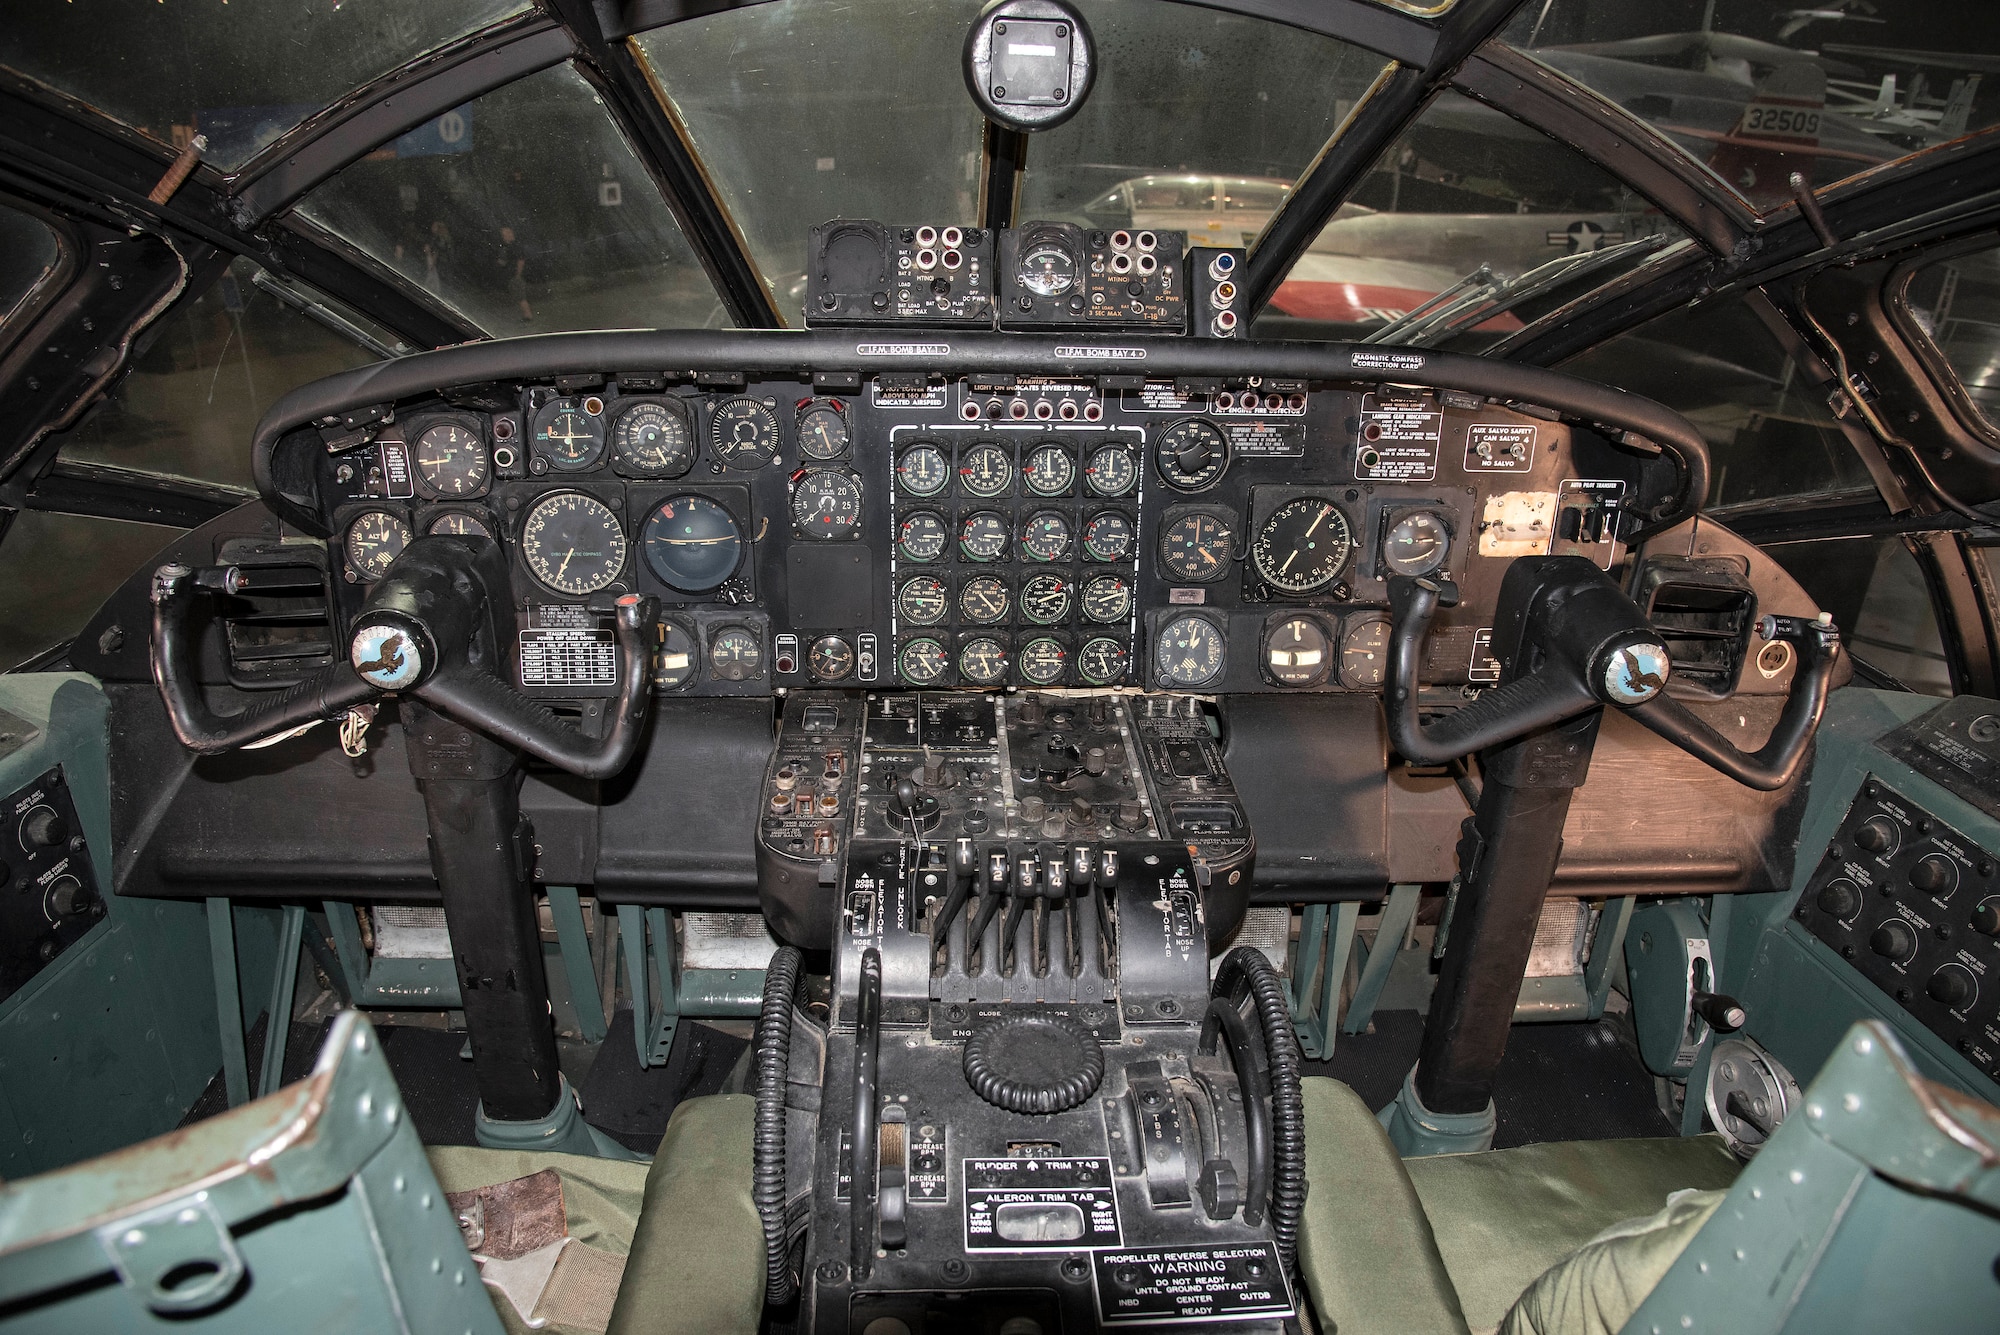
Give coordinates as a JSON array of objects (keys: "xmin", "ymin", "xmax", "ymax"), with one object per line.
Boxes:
[{"xmin": 1300, "ymin": 1021, "xmax": 2000, "ymax": 1335}]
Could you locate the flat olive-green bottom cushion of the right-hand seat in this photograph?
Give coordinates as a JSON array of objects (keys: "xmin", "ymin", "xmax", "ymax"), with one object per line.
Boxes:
[{"xmin": 1404, "ymin": 1135, "xmax": 1738, "ymax": 1331}]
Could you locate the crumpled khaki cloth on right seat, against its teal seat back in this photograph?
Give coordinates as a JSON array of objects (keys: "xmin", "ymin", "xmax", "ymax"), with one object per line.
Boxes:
[{"xmin": 1500, "ymin": 1191, "xmax": 1728, "ymax": 1335}]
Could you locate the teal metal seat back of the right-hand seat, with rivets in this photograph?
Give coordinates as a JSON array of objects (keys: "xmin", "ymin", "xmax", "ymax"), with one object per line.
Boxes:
[{"xmin": 1622, "ymin": 1021, "xmax": 2000, "ymax": 1335}]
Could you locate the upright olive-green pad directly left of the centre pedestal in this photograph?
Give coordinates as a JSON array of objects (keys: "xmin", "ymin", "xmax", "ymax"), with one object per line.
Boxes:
[{"xmin": 610, "ymin": 1093, "xmax": 764, "ymax": 1335}]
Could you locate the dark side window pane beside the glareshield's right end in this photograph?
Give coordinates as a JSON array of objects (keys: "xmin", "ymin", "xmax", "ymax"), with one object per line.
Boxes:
[{"xmin": 1562, "ymin": 298, "xmax": 1874, "ymax": 506}]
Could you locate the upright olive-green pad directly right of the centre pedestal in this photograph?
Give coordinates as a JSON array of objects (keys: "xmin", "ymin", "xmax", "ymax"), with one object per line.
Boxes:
[{"xmin": 1298, "ymin": 1077, "xmax": 1466, "ymax": 1335}]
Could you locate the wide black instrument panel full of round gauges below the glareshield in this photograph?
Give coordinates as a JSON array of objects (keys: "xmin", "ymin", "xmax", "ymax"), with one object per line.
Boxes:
[{"xmin": 316, "ymin": 372, "xmax": 1636, "ymax": 697}]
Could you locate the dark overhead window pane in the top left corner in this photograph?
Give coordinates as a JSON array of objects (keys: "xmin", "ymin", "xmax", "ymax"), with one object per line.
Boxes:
[{"xmin": 0, "ymin": 0, "xmax": 528, "ymax": 170}]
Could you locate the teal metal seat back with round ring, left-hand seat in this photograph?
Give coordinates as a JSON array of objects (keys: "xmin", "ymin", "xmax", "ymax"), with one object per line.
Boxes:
[{"xmin": 0, "ymin": 1011, "xmax": 500, "ymax": 1335}]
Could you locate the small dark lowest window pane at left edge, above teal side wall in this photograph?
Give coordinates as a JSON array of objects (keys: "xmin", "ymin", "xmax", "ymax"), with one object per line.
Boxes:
[{"xmin": 0, "ymin": 510, "xmax": 180, "ymax": 671}]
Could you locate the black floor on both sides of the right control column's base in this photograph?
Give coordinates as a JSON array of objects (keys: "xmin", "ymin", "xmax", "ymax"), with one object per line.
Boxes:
[{"xmin": 1306, "ymin": 1011, "xmax": 1680, "ymax": 1149}]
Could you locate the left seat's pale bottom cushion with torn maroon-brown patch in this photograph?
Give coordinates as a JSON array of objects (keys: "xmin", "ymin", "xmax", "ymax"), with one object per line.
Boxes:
[{"xmin": 426, "ymin": 1145, "xmax": 648, "ymax": 1335}]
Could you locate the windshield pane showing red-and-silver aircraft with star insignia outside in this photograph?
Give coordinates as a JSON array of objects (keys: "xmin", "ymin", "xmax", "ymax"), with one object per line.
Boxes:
[{"xmin": 1270, "ymin": 92, "xmax": 1682, "ymax": 344}]
